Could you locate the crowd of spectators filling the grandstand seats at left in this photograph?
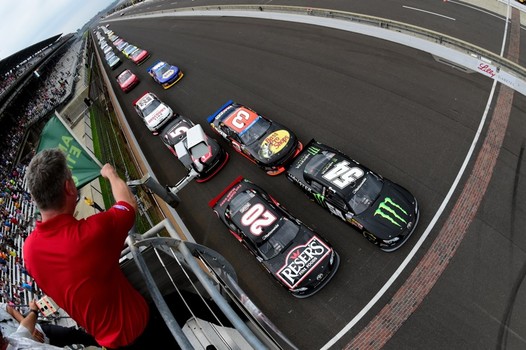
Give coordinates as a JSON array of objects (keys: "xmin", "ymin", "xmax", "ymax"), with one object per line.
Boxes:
[{"xmin": 0, "ymin": 36, "xmax": 83, "ymax": 322}]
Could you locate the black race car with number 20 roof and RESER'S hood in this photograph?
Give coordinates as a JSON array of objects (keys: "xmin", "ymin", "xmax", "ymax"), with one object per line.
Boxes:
[{"xmin": 208, "ymin": 176, "xmax": 340, "ymax": 298}]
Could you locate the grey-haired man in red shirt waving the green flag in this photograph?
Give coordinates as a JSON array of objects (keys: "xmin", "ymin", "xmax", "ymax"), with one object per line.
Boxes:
[{"xmin": 23, "ymin": 149, "xmax": 179, "ymax": 349}]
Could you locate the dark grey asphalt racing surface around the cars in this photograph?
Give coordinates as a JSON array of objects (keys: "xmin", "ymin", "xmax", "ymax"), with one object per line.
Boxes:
[{"xmin": 98, "ymin": 1, "xmax": 526, "ymax": 349}]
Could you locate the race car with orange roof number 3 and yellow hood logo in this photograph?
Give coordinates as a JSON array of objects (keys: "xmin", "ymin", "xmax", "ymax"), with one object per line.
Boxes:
[{"xmin": 207, "ymin": 101, "xmax": 303, "ymax": 176}]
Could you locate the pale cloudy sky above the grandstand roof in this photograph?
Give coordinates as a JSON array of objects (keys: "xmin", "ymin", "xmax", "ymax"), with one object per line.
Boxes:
[{"xmin": 0, "ymin": 0, "xmax": 113, "ymax": 59}]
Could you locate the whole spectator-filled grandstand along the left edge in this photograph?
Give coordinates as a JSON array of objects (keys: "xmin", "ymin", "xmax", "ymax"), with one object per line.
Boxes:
[{"xmin": 0, "ymin": 34, "xmax": 85, "ymax": 318}]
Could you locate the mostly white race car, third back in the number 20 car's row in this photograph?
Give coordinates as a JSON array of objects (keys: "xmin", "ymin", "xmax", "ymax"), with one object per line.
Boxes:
[{"xmin": 133, "ymin": 92, "xmax": 173, "ymax": 135}]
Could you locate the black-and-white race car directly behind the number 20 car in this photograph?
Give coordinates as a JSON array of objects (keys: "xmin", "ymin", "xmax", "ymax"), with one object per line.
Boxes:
[{"xmin": 159, "ymin": 115, "xmax": 228, "ymax": 182}]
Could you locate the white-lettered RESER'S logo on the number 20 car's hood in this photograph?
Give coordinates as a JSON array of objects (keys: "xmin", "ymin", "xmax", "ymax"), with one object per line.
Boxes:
[{"xmin": 276, "ymin": 237, "xmax": 331, "ymax": 288}]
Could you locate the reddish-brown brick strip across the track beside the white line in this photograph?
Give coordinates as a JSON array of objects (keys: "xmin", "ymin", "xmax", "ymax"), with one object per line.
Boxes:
[{"xmin": 344, "ymin": 8, "xmax": 520, "ymax": 350}]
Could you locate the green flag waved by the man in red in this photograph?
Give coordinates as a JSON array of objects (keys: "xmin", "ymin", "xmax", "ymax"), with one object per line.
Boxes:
[{"xmin": 37, "ymin": 112, "xmax": 102, "ymax": 188}]
